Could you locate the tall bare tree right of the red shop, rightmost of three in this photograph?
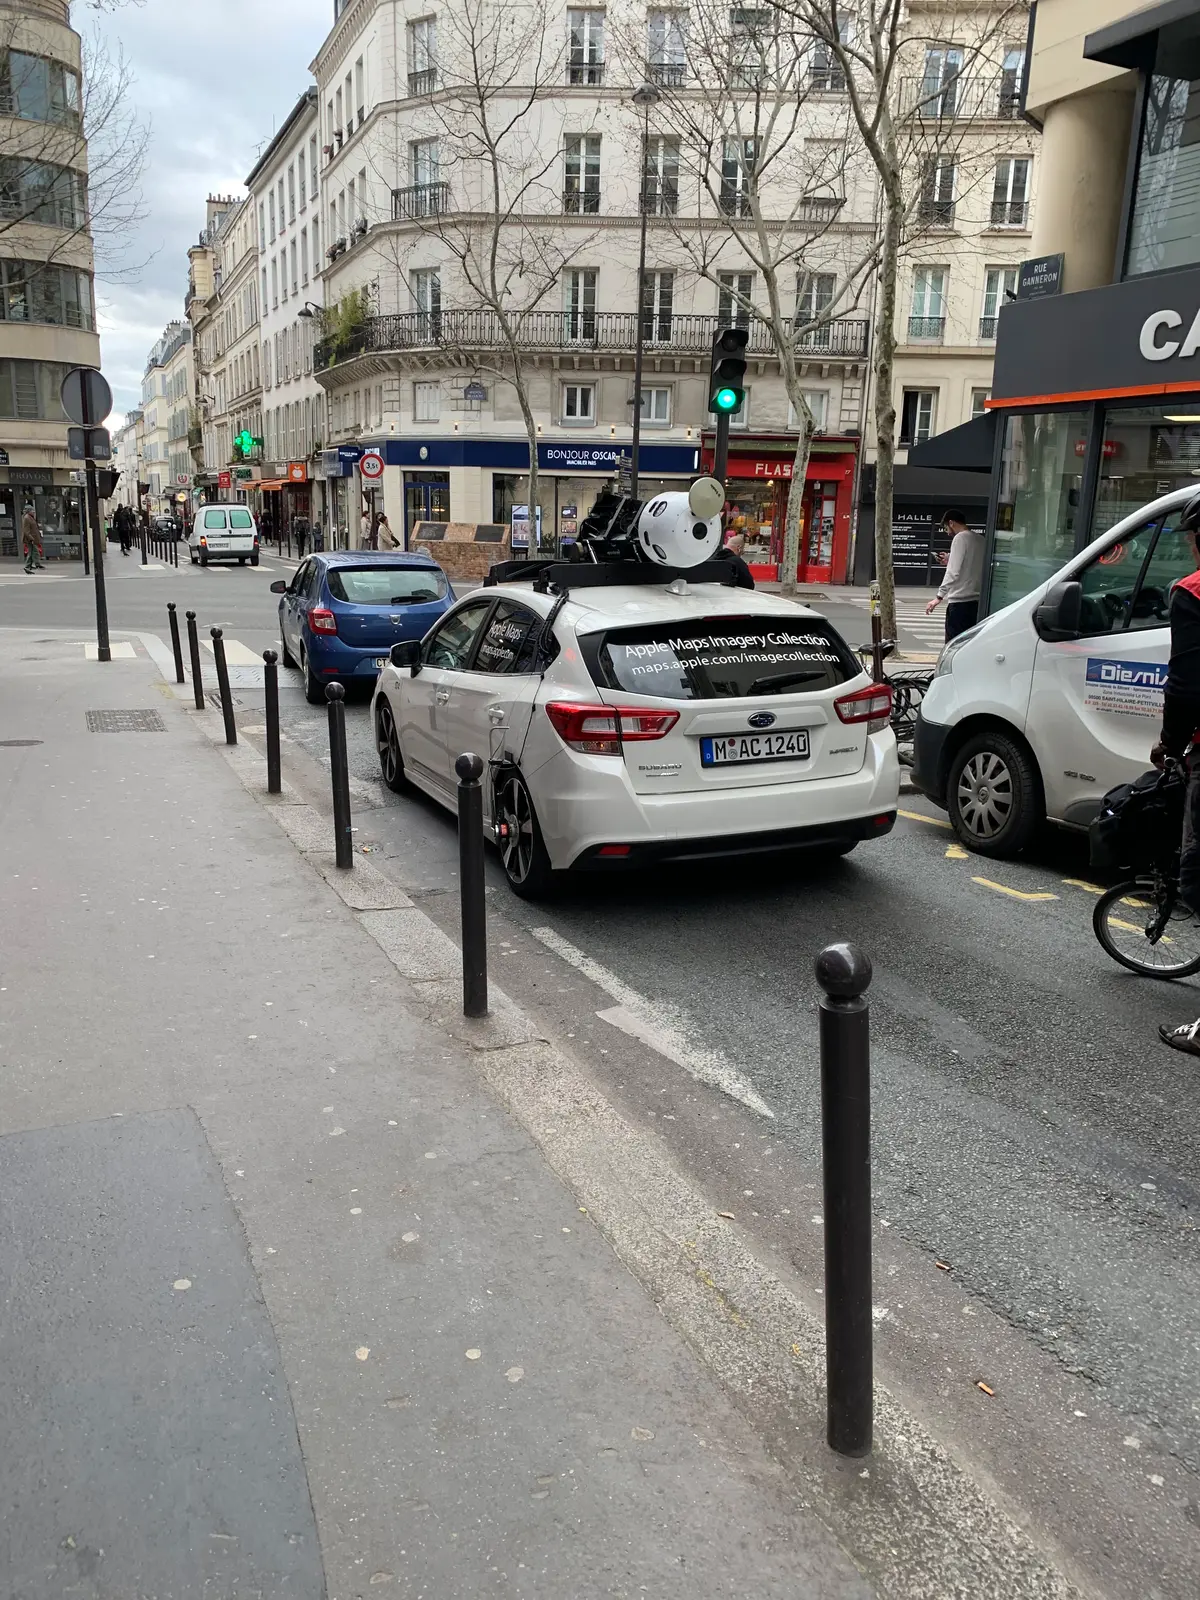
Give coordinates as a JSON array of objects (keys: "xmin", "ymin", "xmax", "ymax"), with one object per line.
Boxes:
[{"xmin": 771, "ymin": 0, "xmax": 1029, "ymax": 637}]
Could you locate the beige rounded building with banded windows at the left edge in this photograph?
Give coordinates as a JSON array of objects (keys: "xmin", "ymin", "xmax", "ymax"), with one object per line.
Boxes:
[{"xmin": 0, "ymin": 0, "xmax": 99, "ymax": 557}]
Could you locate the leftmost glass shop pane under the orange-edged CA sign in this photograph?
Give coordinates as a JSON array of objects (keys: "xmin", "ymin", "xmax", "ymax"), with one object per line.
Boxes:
[{"xmin": 989, "ymin": 411, "xmax": 1088, "ymax": 611}]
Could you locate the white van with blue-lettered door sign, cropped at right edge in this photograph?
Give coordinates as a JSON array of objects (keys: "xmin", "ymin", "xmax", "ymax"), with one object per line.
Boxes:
[{"xmin": 914, "ymin": 485, "xmax": 1200, "ymax": 856}]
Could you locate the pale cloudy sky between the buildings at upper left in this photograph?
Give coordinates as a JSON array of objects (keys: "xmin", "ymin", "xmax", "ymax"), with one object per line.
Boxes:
[{"xmin": 93, "ymin": 0, "xmax": 333, "ymax": 421}]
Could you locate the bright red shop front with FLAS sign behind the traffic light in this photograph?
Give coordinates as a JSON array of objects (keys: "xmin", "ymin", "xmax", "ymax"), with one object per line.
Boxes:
[{"xmin": 702, "ymin": 435, "xmax": 858, "ymax": 584}]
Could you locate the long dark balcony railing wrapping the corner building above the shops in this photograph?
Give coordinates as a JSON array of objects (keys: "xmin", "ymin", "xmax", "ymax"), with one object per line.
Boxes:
[{"xmin": 314, "ymin": 310, "xmax": 870, "ymax": 371}]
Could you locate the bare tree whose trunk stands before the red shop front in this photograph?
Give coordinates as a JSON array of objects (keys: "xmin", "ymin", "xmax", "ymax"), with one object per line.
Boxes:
[{"xmin": 622, "ymin": 0, "xmax": 878, "ymax": 592}]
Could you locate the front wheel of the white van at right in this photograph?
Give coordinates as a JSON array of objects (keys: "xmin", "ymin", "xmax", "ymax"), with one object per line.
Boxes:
[{"xmin": 946, "ymin": 728, "xmax": 1046, "ymax": 858}]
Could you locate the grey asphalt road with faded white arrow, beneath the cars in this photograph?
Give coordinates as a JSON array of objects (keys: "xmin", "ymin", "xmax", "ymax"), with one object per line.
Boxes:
[{"xmin": 0, "ymin": 557, "xmax": 1200, "ymax": 1600}]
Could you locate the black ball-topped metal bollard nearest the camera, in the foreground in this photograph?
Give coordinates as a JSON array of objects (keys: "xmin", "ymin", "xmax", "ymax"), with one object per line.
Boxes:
[{"xmin": 816, "ymin": 944, "xmax": 874, "ymax": 1456}]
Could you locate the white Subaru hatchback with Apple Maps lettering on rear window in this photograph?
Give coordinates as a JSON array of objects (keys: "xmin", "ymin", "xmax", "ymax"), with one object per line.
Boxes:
[{"xmin": 373, "ymin": 563, "xmax": 899, "ymax": 899}]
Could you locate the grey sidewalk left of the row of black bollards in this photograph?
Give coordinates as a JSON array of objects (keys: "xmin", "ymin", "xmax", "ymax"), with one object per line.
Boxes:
[{"xmin": 0, "ymin": 630, "xmax": 872, "ymax": 1600}]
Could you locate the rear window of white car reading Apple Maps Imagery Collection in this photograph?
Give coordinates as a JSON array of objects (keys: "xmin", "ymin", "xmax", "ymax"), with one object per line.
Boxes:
[{"xmin": 586, "ymin": 616, "xmax": 862, "ymax": 699}]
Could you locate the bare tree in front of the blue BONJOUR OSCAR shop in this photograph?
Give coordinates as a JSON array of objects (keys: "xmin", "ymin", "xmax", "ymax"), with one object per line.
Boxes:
[{"xmin": 366, "ymin": 0, "xmax": 598, "ymax": 531}]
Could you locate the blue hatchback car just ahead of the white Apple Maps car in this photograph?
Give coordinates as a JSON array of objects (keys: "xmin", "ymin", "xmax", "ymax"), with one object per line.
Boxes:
[{"xmin": 270, "ymin": 550, "xmax": 454, "ymax": 706}]
